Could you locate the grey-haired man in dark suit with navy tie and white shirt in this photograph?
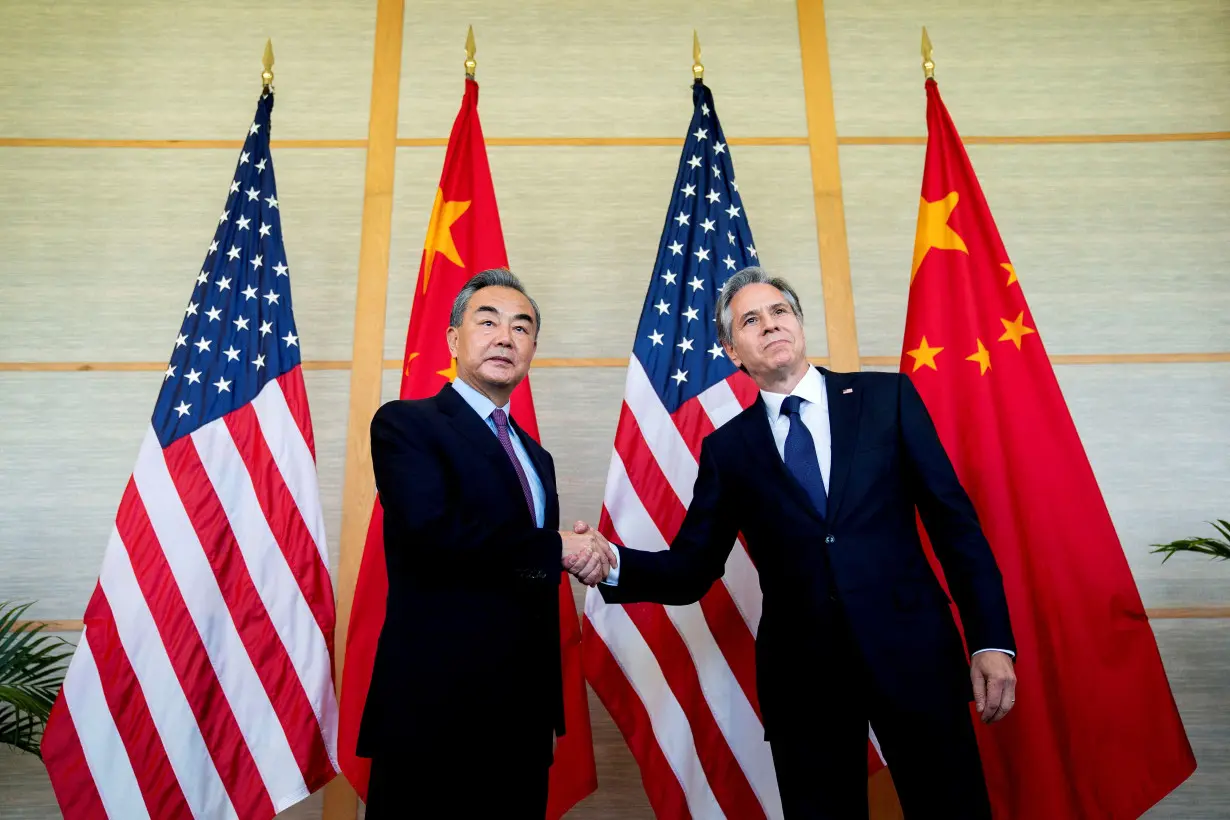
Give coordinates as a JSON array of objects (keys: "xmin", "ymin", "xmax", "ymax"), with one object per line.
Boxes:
[{"xmin": 599, "ymin": 268, "xmax": 1016, "ymax": 820}]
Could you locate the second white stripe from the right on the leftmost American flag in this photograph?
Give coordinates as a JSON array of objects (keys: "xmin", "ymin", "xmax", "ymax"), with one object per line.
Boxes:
[{"xmin": 192, "ymin": 417, "xmax": 337, "ymax": 757}]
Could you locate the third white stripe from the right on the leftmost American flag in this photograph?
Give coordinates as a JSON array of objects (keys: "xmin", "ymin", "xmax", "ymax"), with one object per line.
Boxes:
[{"xmin": 133, "ymin": 427, "xmax": 303, "ymax": 795}]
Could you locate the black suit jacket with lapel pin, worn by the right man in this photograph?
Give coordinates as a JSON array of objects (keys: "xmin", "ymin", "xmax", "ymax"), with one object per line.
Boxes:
[{"xmin": 599, "ymin": 370, "xmax": 1016, "ymax": 733}]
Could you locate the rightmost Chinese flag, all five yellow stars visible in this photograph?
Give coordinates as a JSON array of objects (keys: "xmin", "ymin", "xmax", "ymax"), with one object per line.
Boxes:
[{"xmin": 889, "ymin": 80, "xmax": 1196, "ymax": 820}]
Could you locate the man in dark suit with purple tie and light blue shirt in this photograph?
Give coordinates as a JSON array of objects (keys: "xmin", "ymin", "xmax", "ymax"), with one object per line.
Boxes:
[{"xmin": 358, "ymin": 269, "xmax": 610, "ymax": 820}]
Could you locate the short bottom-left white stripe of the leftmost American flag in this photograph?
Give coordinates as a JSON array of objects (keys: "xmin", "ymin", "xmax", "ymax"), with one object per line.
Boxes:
[{"xmin": 64, "ymin": 627, "xmax": 150, "ymax": 820}]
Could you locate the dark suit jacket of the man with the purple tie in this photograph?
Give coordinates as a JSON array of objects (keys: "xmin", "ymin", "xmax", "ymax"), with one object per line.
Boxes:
[{"xmin": 358, "ymin": 385, "xmax": 565, "ymax": 757}]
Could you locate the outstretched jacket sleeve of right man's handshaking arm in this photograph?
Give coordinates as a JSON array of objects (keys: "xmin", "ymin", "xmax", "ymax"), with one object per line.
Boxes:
[{"xmin": 598, "ymin": 439, "xmax": 739, "ymax": 606}]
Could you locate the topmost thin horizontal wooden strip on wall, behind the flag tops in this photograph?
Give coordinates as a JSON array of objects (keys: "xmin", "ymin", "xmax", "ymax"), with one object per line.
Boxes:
[{"xmin": 0, "ymin": 132, "xmax": 1230, "ymax": 150}]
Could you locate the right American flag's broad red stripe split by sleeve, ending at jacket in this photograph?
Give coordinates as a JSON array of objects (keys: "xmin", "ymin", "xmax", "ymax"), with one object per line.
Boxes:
[{"xmin": 615, "ymin": 413, "xmax": 760, "ymax": 718}]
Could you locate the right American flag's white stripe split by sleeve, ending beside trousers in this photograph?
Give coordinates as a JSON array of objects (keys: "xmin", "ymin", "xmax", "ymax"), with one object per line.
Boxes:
[{"xmin": 606, "ymin": 460, "xmax": 781, "ymax": 818}]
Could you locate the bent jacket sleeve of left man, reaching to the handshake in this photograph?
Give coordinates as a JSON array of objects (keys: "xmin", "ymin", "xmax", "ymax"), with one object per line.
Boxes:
[{"xmin": 371, "ymin": 404, "xmax": 562, "ymax": 583}]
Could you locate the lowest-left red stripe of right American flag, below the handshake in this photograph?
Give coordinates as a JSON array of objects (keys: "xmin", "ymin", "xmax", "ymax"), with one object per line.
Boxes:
[{"xmin": 581, "ymin": 614, "xmax": 691, "ymax": 820}]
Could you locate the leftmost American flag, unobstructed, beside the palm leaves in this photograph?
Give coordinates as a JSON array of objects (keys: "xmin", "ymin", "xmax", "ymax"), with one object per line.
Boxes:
[{"xmin": 42, "ymin": 91, "xmax": 337, "ymax": 820}]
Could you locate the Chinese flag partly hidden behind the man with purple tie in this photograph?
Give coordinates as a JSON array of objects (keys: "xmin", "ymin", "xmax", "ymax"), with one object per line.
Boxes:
[{"xmin": 337, "ymin": 80, "xmax": 598, "ymax": 820}]
